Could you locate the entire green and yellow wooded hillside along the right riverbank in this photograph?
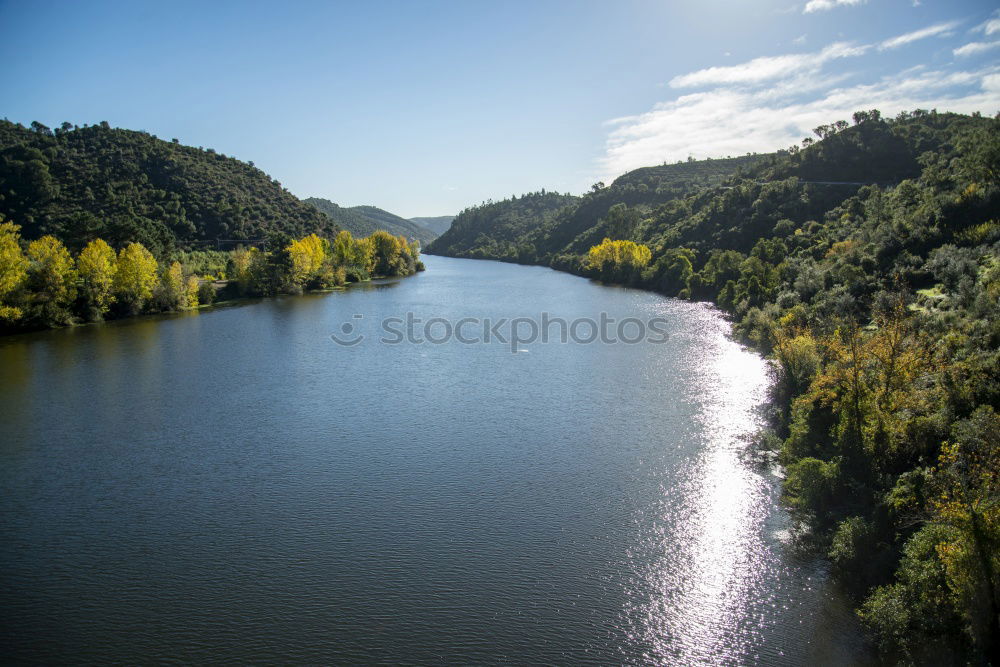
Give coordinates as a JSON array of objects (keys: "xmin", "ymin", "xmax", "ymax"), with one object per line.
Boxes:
[{"xmin": 428, "ymin": 111, "xmax": 1000, "ymax": 664}]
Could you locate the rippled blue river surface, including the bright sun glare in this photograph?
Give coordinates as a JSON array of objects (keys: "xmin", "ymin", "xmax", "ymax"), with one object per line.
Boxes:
[{"xmin": 0, "ymin": 257, "xmax": 864, "ymax": 664}]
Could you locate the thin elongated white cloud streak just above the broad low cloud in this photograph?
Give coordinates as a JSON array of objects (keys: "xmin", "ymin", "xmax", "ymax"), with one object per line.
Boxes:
[{"xmin": 670, "ymin": 42, "xmax": 869, "ymax": 88}]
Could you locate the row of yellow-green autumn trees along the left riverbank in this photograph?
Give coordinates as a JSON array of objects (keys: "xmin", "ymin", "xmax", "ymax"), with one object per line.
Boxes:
[{"xmin": 0, "ymin": 227, "xmax": 424, "ymax": 335}]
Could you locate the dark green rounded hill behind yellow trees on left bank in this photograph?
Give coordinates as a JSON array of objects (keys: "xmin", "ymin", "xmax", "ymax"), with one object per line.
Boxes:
[{"xmin": 0, "ymin": 120, "xmax": 336, "ymax": 256}]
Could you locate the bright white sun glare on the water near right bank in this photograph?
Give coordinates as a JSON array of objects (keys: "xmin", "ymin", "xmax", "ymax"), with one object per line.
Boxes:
[{"xmin": 632, "ymin": 310, "xmax": 773, "ymax": 663}]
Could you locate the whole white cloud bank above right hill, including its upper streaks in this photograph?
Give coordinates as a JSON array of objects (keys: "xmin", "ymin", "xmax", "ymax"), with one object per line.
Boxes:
[{"xmin": 597, "ymin": 23, "xmax": 1000, "ymax": 180}]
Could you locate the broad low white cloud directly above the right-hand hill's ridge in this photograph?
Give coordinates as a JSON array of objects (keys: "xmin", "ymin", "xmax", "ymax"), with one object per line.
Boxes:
[{"xmin": 599, "ymin": 57, "xmax": 1000, "ymax": 182}]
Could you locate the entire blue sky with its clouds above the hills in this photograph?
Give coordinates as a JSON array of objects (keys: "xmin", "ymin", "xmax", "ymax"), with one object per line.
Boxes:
[{"xmin": 0, "ymin": 0, "xmax": 1000, "ymax": 217}]
